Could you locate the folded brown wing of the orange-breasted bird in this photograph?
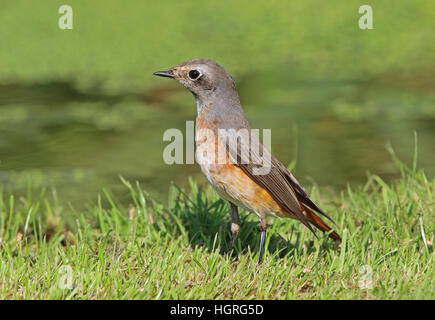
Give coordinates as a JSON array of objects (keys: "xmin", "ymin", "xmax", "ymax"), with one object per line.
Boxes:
[{"xmin": 219, "ymin": 130, "xmax": 338, "ymax": 233}]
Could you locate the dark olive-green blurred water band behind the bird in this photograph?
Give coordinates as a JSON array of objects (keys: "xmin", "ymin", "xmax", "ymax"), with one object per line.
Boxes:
[{"xmin": 0, "ymin": 78, "xmax": 435, "ymax": 205}]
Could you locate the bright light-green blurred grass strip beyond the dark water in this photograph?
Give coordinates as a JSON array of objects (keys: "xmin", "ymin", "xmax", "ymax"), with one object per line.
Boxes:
[{"xmin": 0, "ymin": 0, "xmax": 435, "ymax": 93}]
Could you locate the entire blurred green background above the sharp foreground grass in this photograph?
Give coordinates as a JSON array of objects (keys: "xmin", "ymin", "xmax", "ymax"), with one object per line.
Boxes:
[{"xmin": 0, "ymin": 0, "xmax": 435, "ymax": 206}]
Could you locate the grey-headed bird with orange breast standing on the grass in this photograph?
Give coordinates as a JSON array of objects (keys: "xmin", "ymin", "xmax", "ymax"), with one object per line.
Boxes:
[{"xmin": 153, "ymin": 59, "xmax": 341, "ymax": 266}]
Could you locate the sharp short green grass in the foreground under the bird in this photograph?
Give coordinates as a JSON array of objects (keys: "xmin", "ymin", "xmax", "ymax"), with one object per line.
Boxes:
[{"xmin": 0, "ymin": 154, "xmax": 435, "ymax": 299}]
